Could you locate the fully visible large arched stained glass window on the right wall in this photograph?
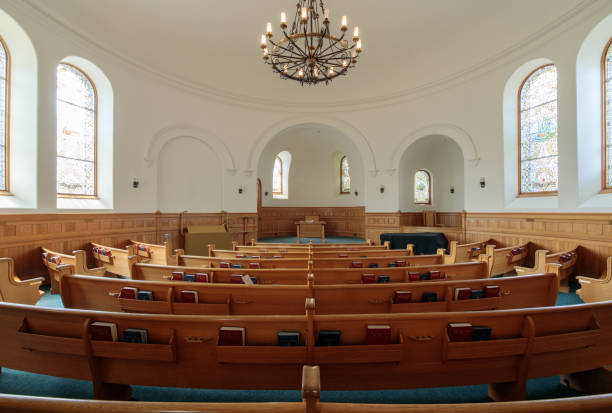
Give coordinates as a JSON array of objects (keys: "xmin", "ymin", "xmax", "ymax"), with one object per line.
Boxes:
[{"xmin": 519, "ymin": 65, "xmax": 559, "ymax": 195}]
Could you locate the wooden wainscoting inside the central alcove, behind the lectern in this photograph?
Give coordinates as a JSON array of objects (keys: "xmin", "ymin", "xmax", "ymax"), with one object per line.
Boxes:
[{"xmin": 259, "ymin": 207, "xmax": 365, "ymax": 238}]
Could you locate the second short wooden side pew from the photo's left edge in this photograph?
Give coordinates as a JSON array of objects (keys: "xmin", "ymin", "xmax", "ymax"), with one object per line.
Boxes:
[{"xmin": 42, "ymin": 247, "xmax": 106, "ymax": 294}]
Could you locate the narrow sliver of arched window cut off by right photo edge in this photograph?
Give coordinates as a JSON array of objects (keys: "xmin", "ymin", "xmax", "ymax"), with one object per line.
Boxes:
[{"xmin": 601, "ymin": 39, "xmax": 612, "ymax": 190}]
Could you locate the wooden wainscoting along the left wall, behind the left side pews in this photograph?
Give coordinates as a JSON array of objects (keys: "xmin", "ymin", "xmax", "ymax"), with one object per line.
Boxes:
[{"xmin": 0, "ymin": 212, "xmax": 257, "ymax": 278}]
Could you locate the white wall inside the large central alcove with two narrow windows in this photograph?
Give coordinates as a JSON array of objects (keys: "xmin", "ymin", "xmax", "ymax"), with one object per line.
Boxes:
[{"xmin": 257, "ymin": 124, "xmax": 365, "ymax": 206}]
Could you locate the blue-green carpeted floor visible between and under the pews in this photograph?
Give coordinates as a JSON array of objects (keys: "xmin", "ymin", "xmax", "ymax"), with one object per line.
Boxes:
[{"xmin": 0, "ymin": 237, "xmax": 582, "ymax": 404}]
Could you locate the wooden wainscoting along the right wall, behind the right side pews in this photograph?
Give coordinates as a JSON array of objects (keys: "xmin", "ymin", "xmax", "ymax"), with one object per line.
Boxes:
[{"xmin": 465, "ymin": 213, "xmax": 612, "ymax": 277}]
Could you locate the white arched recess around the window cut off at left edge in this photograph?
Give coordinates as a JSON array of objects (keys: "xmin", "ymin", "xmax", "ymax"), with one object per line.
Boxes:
[{"xmin": 0, "ymin": 10, "xmax": 38, "ymax": 210}]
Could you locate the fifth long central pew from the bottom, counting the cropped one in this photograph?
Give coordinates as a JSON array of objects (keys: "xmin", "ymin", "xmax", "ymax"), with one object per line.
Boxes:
[{"xmin": 178, "ymin": 255, "xmax": 443, "ymax": 269}]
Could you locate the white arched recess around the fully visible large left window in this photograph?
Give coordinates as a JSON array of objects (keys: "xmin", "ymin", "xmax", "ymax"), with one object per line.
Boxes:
[{"xmin": 57, "ymin": 56, "xmax": 115, "ymax": 209}]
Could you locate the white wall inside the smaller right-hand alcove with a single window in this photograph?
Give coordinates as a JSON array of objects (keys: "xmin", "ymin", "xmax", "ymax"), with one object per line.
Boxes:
[{"xmin": 399, "ymin": 136, "xmax": 464, "ymax": 212}]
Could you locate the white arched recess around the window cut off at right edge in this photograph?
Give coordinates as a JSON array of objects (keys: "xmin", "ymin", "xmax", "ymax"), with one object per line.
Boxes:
[{"xmin": 576, "ymin": 15, "xmax": 612, "ymax": 208}]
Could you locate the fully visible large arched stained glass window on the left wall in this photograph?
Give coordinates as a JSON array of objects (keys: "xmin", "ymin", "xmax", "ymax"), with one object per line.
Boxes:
[{"xmin": 56, "ymin": 63, "xmax": 97, "ymax": 197}]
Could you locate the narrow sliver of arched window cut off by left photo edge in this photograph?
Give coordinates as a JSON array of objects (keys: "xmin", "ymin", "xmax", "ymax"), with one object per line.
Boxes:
[{"xmin": 0, "ymin": 37, "xmax": 10, "ymax": 193}]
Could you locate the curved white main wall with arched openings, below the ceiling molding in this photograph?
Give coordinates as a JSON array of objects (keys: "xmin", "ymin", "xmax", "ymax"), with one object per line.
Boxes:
[{"xmin": 0, "ymin": 0, "xmax": 612, "ymax": 213}]
